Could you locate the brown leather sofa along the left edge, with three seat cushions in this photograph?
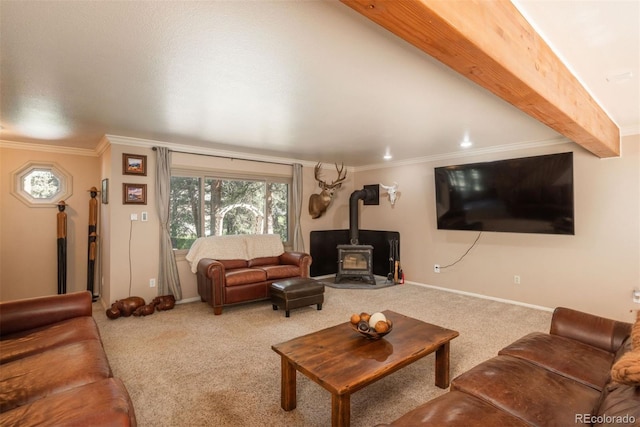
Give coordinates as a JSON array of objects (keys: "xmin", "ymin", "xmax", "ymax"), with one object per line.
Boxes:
[{"xmin": 0, "ymin": 291, "xmax": 136, "ymax": 426}]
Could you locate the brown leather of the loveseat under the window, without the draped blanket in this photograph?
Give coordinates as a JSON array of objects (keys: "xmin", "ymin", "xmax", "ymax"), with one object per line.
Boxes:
[{"xmin": 197, "ymin": 252, "xmax": 311, "ymax": 315}]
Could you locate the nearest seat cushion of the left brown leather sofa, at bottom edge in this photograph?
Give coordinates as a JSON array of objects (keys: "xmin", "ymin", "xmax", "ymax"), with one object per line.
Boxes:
[{"xmin": 0, "ymin": 378, "xmax": 136, "ymax": 427}]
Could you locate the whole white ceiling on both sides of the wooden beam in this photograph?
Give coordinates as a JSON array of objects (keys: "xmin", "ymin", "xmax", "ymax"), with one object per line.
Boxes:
[{"xmin": 0, "ymin": 0, "xmax": 640, "ymax": 166}]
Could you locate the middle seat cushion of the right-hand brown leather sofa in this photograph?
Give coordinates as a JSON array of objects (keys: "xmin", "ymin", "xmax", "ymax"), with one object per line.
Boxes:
[{"xmin": 451, "ymin": 356, "xmax": 600, "ymax": 426}]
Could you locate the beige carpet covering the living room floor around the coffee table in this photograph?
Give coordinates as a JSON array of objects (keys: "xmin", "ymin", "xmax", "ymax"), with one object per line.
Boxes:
[{"xmin": 94, "ymin": 284, "xmax": 551, "ymax": 427}]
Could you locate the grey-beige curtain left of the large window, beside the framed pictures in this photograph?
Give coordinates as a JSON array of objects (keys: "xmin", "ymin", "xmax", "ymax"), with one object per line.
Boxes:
[{"xmin": 156, "ymin": 147, "xmax": 182, "ymax": 300}]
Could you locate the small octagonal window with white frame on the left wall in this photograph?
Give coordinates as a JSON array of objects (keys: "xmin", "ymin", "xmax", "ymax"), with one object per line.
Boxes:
[{"xmin": 11, "ymin": 162, "xmax": 72, "ymax": 207}]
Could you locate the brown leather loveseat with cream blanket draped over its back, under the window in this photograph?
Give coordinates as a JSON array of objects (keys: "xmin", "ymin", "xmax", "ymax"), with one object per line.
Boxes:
[{"xmin": 186, "ymin": 234, "xmax": 311, "ymax": 315}]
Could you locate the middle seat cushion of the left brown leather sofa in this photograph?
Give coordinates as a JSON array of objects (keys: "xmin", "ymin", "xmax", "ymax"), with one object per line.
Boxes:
[{"xmin": 0, "ymin": 340, "xmax": 111, "ymax": 412}]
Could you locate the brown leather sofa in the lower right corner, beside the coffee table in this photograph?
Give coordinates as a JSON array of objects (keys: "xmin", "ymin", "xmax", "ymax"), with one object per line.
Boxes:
[{"xmin": 383, "ymin": 308, "xmax": 640, "ymax": 427}]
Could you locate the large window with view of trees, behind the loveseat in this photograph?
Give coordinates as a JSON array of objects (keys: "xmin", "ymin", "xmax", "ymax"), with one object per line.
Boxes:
[{"xmin": 170, "ymin": 173, "xmax": 290, "ymax": 249}]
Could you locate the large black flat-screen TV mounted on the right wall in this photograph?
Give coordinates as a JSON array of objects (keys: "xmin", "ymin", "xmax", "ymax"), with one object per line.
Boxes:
[{"xmin": 435, "ymin": 153, "xmax": 575, "ymax": 234}]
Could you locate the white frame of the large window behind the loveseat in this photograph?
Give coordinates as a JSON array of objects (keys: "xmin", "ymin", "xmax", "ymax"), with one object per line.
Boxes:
[{"xmin": 171, "ymin": 167, "xmax": 296, "ymax": 256}]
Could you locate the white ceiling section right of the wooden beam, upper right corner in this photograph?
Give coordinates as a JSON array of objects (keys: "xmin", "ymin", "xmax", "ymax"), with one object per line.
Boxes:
[{"xmin": 514, "ymin": 0, "xmax": 640, "ymax": 133}]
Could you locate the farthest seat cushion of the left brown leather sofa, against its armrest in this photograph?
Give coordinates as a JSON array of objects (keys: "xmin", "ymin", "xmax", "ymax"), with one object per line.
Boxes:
[{"xmin": 0, "ymin": 316, "xmax": 100, "ymax": 364}]
